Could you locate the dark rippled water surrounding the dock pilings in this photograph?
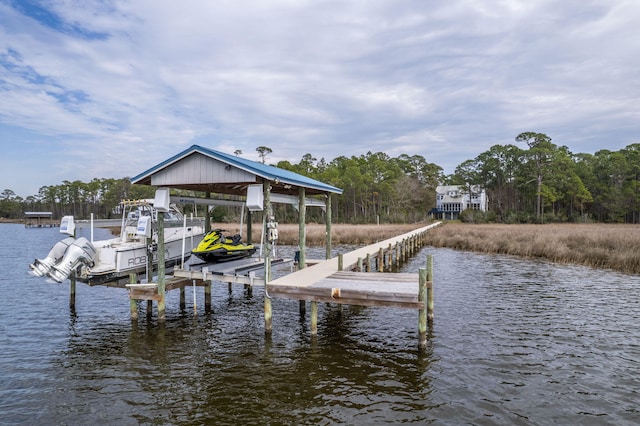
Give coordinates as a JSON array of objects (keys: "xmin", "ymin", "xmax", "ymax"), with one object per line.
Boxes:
[{"xmin": 0, "ymin": 224, "xmax": 640, "ymax": 425}]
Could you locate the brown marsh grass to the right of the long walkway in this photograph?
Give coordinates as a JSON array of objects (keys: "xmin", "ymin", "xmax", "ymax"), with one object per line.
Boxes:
[{"xmin": 427, "ymin": 223, "xmax": 640, "ymax": 274}]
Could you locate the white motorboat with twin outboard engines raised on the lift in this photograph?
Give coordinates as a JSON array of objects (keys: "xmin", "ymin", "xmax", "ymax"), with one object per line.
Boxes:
[{"xmin": 29, "ymin": 200, "xmax": 204, "ymax": 285}]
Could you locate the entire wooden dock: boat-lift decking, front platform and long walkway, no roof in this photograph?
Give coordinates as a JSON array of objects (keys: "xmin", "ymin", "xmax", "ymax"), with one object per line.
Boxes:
[{"xmin": 122, "ymin": 222, "xmax": 440, "ymax": 347}]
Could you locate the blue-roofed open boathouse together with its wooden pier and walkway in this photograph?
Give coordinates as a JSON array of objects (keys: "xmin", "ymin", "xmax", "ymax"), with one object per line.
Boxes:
[{"xmin": 129, "ymin": 145, "xmax": 437, "ymax": 346}]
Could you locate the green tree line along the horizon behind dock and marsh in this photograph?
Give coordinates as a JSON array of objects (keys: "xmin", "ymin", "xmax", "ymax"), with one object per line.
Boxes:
[{"xmin": 0, "ymin": 132, "xmax": 640, "ymax": 223}]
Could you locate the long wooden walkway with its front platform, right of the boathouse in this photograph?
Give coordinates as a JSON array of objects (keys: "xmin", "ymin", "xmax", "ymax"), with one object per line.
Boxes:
[{"xmin": 264, "ymin": 222, "xmax": 440, "ymax": 346}]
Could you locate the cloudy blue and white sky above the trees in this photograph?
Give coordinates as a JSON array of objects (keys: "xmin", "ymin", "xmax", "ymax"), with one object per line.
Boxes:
[{"xmin": 0, "ymin": 0, "xmax": 640, "ymax": 198}]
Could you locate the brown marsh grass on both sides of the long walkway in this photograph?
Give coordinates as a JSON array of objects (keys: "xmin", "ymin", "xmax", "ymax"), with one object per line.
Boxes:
[{"xmin": 7, "ymin": 218, "xmax": 640, "ymax": 274}]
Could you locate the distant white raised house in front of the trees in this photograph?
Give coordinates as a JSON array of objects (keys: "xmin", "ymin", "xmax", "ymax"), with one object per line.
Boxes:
[{"xmin": 431, "ymin": 185, "xmax": 489, "ymax": 220}]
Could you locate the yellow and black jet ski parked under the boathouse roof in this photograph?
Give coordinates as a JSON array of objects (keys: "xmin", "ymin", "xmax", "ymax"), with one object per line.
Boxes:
[{"xmin": 191, "ymin": 229, "xmax": 256, "ymax": 263}]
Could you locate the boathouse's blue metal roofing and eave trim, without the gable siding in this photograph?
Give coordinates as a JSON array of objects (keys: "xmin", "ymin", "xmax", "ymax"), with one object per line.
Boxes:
[{"xmin": 131, "ymin": 145, "xmax": 342, "ymax": 194}]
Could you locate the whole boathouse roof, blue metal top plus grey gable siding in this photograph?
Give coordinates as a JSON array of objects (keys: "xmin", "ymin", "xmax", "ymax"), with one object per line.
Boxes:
[{"xmin": 131, "ymin": 145, "xmax": 342, "ymax": 195}]
